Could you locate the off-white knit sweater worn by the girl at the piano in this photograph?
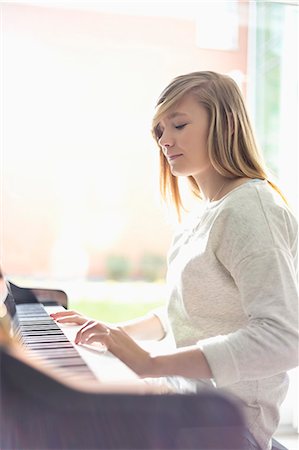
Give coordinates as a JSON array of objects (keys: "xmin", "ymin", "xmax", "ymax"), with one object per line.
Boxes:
[{"xmin": 162, "ymin": 180, "xmax": 298, "ymax": 449}]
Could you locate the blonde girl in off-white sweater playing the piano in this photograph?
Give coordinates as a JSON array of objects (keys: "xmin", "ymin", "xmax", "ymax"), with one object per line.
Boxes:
[{"xmin": 54, "ymin": 72, "xmax": 298, "ymax": 450}]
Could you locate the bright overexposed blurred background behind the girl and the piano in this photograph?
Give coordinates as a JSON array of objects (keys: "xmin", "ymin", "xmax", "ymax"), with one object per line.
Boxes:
[{"xmin": 0, "ymin": 0, "xmax": 299, "ymax": 442}]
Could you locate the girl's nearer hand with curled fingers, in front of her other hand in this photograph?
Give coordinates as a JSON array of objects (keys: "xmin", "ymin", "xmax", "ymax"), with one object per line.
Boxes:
[{"xmin": 75, "ymin": 320, "xmax": 153, "ymax": 377}]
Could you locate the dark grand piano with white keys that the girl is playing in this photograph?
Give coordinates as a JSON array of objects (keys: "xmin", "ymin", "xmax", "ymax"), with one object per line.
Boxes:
[{"xmin": 0, "ymin": 268, "xmax": 244, "ymax": 450}]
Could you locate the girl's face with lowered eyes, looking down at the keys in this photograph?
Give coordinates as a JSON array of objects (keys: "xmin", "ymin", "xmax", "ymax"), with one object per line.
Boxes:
[{"xmin": 157, "ymin": 94, "xmax": 211, "ymax": 179}]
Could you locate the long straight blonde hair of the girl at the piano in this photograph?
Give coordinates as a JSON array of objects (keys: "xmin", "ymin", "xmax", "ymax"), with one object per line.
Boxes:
[{"xmin": 152, "ymin": 71, "xmax": 286, "ymax": 217}]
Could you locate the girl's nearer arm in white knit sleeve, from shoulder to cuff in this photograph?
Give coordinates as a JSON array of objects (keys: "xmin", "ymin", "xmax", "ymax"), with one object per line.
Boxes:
[{"xmin": 198, "ymin": 195, "xmax": 298, "ymax": 387}]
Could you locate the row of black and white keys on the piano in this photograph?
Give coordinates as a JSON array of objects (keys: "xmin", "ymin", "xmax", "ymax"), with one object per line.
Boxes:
[{"xmin": 15, "ymin": 303, "xmax": 98, "ymax": 383}]
